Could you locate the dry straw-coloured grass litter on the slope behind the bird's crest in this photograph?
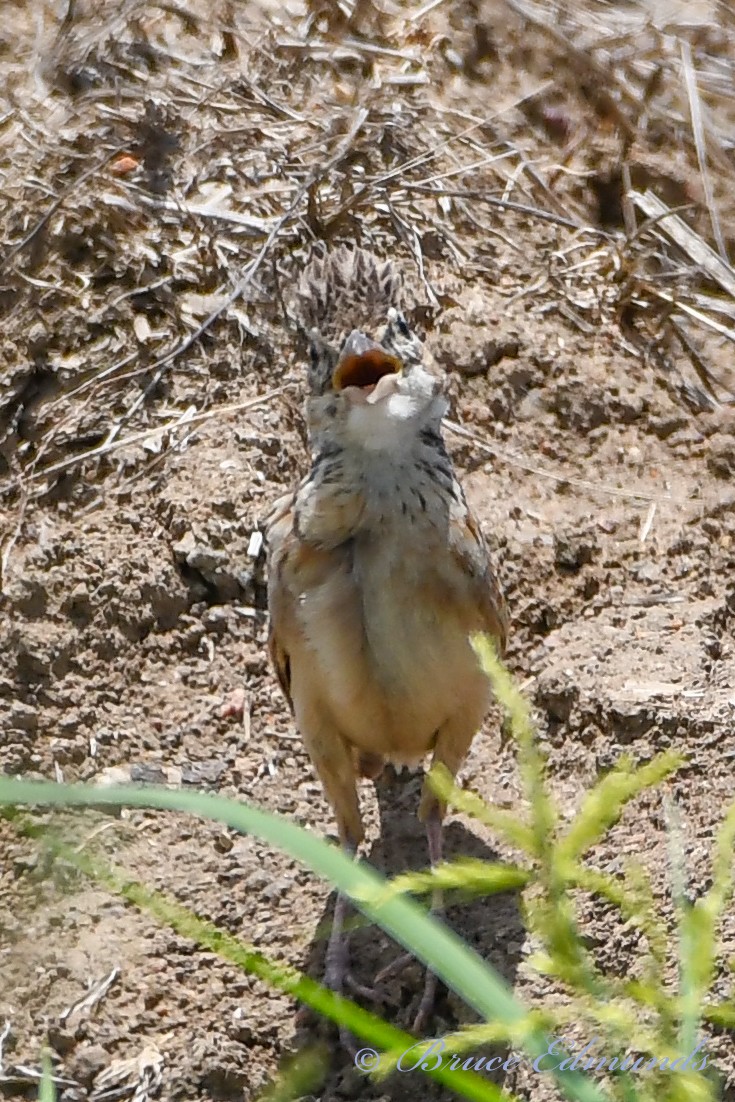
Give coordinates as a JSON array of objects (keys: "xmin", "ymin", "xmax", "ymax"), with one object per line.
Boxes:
[{"xmin": 0, "ymin": 0, "xmax": 735, "ymax": 515}]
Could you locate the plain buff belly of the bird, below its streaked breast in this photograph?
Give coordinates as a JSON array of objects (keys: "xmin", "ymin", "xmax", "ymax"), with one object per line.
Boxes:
[{"xmin": 300, "ymin": 533, "xmax": 488, "ymax": 764}]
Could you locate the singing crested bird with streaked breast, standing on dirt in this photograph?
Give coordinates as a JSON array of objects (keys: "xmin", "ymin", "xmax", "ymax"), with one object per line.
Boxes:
[{"xmin": 266, "ymin": 245, "xmax": 509, "ymax": 1031}]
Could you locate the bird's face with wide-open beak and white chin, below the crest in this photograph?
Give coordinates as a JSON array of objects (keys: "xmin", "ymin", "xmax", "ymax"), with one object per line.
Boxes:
[{"xmin": 309, "ymin": 306, "xmax": 446, "ymax": 451}]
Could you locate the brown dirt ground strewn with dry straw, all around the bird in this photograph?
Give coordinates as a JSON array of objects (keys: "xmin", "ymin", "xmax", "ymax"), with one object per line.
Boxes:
[{"xmin": 0, "ymin": 0, "xmax": 735, "ymax": 1102}]
